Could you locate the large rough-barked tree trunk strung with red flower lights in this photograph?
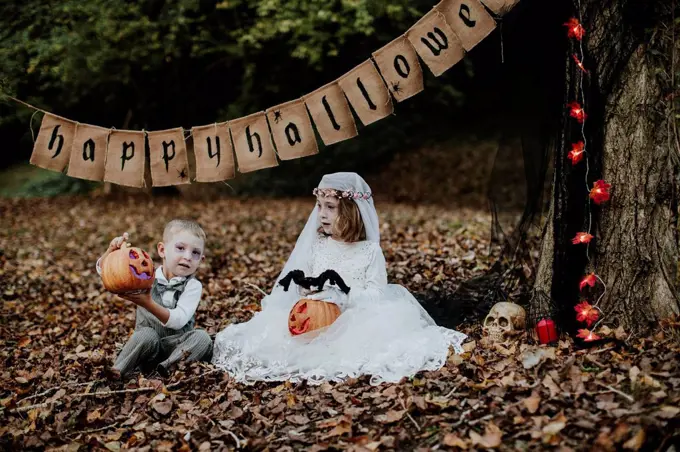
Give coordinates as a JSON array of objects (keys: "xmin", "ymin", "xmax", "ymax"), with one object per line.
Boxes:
[{"xmin": 536, "ymin": 0, "xmax": 680, "ymax": 331}]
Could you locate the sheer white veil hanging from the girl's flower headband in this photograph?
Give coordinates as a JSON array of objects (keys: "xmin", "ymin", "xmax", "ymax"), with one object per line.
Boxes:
[{"xmin": 262, "ymin": 173, "xmax": 380, "ymax": 305}]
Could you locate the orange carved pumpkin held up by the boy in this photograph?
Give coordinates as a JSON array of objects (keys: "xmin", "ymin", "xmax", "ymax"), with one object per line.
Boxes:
[{"xmin": 101, "ymin": 246, "xmax": 154, "ymax": 293}]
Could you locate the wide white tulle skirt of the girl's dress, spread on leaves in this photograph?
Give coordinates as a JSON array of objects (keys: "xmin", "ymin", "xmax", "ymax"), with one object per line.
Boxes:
[{"xmin": 213, "ymin": 285, "xmax": 466, "ymax": 384}]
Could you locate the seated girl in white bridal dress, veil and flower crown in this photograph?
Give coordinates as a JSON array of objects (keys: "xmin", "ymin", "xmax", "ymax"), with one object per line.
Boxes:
[{"xmin": 213, "ymin": 173, "xmax": 466, "ymax": 384}]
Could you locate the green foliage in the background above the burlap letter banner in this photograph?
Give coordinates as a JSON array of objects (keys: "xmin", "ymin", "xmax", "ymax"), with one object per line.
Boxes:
[{"xmin": 0, "ymin": 0, "xmax": 456, "ymax": 122}]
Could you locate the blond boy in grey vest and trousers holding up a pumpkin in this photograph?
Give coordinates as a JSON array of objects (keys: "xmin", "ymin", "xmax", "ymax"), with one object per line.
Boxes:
[{"xmin": 97, "ymin": 220, "xmax": 212, "ymax": 379}]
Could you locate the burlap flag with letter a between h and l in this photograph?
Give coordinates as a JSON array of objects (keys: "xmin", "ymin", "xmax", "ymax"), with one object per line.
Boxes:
[{"xmin": 266, "ymin": 99, "xmax": 319, "ymax": 160}]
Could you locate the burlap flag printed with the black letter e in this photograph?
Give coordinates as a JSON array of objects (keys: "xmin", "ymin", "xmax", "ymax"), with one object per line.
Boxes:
[{"xmin": 435, "ymin": 0, "xmax": 496, "ymax": 51}]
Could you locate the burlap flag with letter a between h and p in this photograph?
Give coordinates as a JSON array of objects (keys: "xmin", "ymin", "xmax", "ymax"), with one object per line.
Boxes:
[{"xmin": 67, "ymin": 124, "xmax": 111, "ymax": 181}]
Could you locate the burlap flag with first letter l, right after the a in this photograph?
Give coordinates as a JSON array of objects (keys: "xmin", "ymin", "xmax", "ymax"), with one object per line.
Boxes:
[{"xmin": 303, "ymin": 82, "xmax": 357, "ymax": 146}]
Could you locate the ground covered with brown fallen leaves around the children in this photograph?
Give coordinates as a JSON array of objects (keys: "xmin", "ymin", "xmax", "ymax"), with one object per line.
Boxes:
[{"xmin": 0, "ymin": 196, "xmax": 680, "ymax": 451}]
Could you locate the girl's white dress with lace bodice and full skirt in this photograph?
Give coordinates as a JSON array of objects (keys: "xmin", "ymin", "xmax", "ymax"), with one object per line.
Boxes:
[{"xmin": 213, "ymin": 233, "xmax": 466, "ymax": 384}]
